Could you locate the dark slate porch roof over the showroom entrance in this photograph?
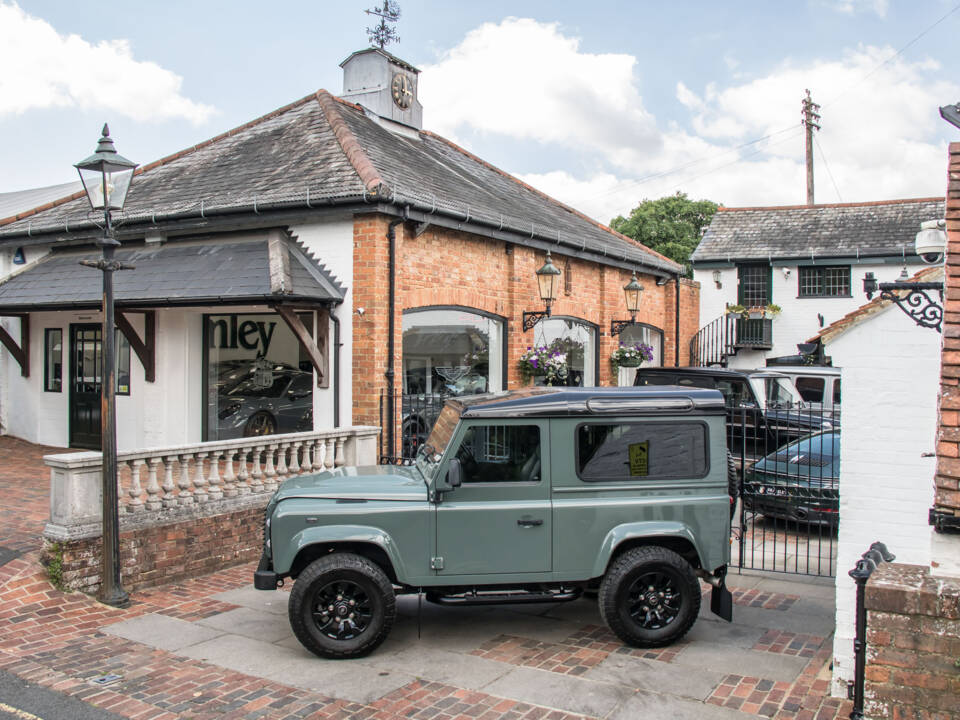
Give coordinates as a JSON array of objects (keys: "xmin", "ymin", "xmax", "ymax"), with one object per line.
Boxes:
[{"xmin": 0, "ymin": 236, "xmax": 344, "ymax": 312}]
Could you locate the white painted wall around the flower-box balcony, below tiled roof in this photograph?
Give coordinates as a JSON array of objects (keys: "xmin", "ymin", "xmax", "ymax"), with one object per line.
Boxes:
[{"xmin": 693, "ymin": 260, "xmax": 917, "ymax": 368}]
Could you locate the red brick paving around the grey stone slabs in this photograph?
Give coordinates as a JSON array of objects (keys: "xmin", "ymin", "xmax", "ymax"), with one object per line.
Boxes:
[{"xmin": 0, "ymin": 438, "xmax": 850, "ymax": 720}]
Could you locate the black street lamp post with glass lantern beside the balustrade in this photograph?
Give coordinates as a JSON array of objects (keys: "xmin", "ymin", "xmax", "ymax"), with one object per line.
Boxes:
[{"xmin": 74, "ymin": 125, "xmax": 137, "ymax": 607}]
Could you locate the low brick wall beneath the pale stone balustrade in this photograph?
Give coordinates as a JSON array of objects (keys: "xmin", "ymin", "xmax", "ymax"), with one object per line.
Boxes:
[{"xmin": 41, "ymin": 504, "xmax": 269, "ymax": 594}]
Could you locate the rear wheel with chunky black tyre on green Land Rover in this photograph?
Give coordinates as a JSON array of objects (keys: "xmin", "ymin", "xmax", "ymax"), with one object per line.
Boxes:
[{"xmin": 599, "ymin": 545, "xmax": 700, "ymax": 647}]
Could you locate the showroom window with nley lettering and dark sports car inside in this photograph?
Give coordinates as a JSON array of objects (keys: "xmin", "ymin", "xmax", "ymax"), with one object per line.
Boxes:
[{"xmin": 204, "ymin": 313, "xmax": 314, "ymax": 441}]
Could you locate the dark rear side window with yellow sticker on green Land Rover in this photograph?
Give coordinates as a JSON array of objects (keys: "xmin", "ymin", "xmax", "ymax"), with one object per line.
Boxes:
[{"xmin": 576, "ymin": 423, "xmax": 708, "ymax": 482}]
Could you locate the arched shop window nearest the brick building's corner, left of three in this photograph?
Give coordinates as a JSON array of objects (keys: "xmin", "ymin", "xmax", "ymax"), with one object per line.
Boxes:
[{"xmin": 403, "ymin": 308, "xmax": 504, "ymax": 396}]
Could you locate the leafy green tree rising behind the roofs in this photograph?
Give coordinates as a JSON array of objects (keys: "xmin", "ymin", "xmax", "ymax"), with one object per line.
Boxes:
[{"xmin": 610, "ymin": 192, "xmax": 718, "ymax": 275}]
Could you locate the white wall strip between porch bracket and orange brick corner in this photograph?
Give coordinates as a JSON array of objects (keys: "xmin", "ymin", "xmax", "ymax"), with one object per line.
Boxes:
[{"xmin": 291, "ymin": 218, "xmax": 353, "ymax": 430}]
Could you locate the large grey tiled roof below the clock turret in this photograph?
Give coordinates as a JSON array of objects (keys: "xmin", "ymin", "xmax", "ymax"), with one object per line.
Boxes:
[{"xmin": 0, "ymin": 90, "xmax": 682, "ymax": 274}]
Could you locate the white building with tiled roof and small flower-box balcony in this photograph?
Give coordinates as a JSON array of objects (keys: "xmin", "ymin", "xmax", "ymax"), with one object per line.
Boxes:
[{"xmin": 691, "ymin": 198, "xmax": 944, "ymax": 368}]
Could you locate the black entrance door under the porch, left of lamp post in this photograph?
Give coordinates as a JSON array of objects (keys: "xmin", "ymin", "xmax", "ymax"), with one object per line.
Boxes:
[{"xmin": 70, "ymin": 325, "xmax": 102, "ymax": 450}]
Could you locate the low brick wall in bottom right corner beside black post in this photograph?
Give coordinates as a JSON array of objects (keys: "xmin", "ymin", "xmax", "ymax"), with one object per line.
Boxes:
[{"xmin": 865, "ymin": 563, "xmax": 960, "ymax": 720}]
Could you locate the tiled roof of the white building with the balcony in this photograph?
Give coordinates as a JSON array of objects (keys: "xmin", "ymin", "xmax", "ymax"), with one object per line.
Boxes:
[{"xmin": 692, "ymin": 198, "xmax": 944, "ymax": 264}]
